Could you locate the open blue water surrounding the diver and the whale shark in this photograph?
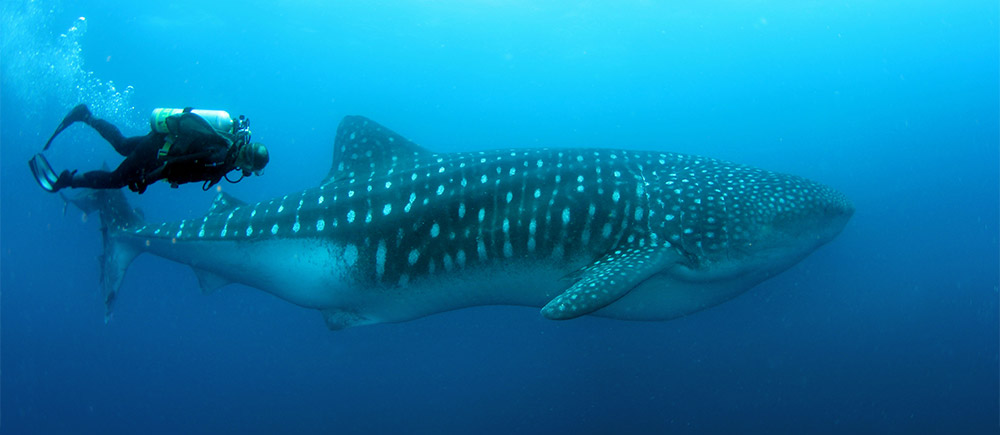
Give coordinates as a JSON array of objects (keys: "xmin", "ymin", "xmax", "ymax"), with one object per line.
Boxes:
[{"xmin": 0, "ymin": 0, "xmax": 1000, "ymax": 434}]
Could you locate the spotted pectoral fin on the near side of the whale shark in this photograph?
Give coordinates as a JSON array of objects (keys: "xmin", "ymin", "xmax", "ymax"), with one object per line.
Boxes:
[{"xmin": 542, "ymin": 244, "xmax": 676, "ymax": 320}]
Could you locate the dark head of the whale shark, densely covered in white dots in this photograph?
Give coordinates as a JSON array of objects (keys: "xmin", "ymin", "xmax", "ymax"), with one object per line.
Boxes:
[{"xmin": 650, "ymin": 157, "xmax": 854, "ymax": 278}]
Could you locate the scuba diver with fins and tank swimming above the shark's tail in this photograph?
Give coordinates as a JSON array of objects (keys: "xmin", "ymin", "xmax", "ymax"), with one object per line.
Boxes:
[{"xmin": 28, "ymin": 104, "xmax": 269, "ymax": 194}]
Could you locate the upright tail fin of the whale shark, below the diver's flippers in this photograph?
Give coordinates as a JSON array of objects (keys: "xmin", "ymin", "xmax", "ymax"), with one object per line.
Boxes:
[{"xmin": 63, "ymin": 189, "xmax": 143, "ymax": 321}]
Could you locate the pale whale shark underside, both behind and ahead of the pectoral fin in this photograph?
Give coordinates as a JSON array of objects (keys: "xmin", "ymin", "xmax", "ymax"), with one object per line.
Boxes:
[{"xmin": 141, "ymin": 238, "xmax": 788, "ymax": 329}]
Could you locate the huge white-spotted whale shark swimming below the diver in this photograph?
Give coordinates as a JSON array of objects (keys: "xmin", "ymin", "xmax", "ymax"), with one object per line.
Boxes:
[{"xmin": 70, "ymin": 116, "xmax": 854, "ymax": 329}]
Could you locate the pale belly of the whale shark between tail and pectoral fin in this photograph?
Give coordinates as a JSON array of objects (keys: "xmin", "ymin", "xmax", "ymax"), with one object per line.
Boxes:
[{"xmin": 145, "ymin": 235, "xmax": 569, "ymax": 327}]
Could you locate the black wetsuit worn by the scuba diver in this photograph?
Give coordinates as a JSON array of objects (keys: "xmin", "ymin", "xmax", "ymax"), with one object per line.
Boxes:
[{"xmin": 70, "ymin": 113, "xmax": 237, "ymax": 193}]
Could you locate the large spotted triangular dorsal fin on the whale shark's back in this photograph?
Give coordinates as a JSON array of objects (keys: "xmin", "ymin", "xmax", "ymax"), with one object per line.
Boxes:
[{"xmin": 320, "ymin": 116, "xmax": 434, "ymax": 184}]
